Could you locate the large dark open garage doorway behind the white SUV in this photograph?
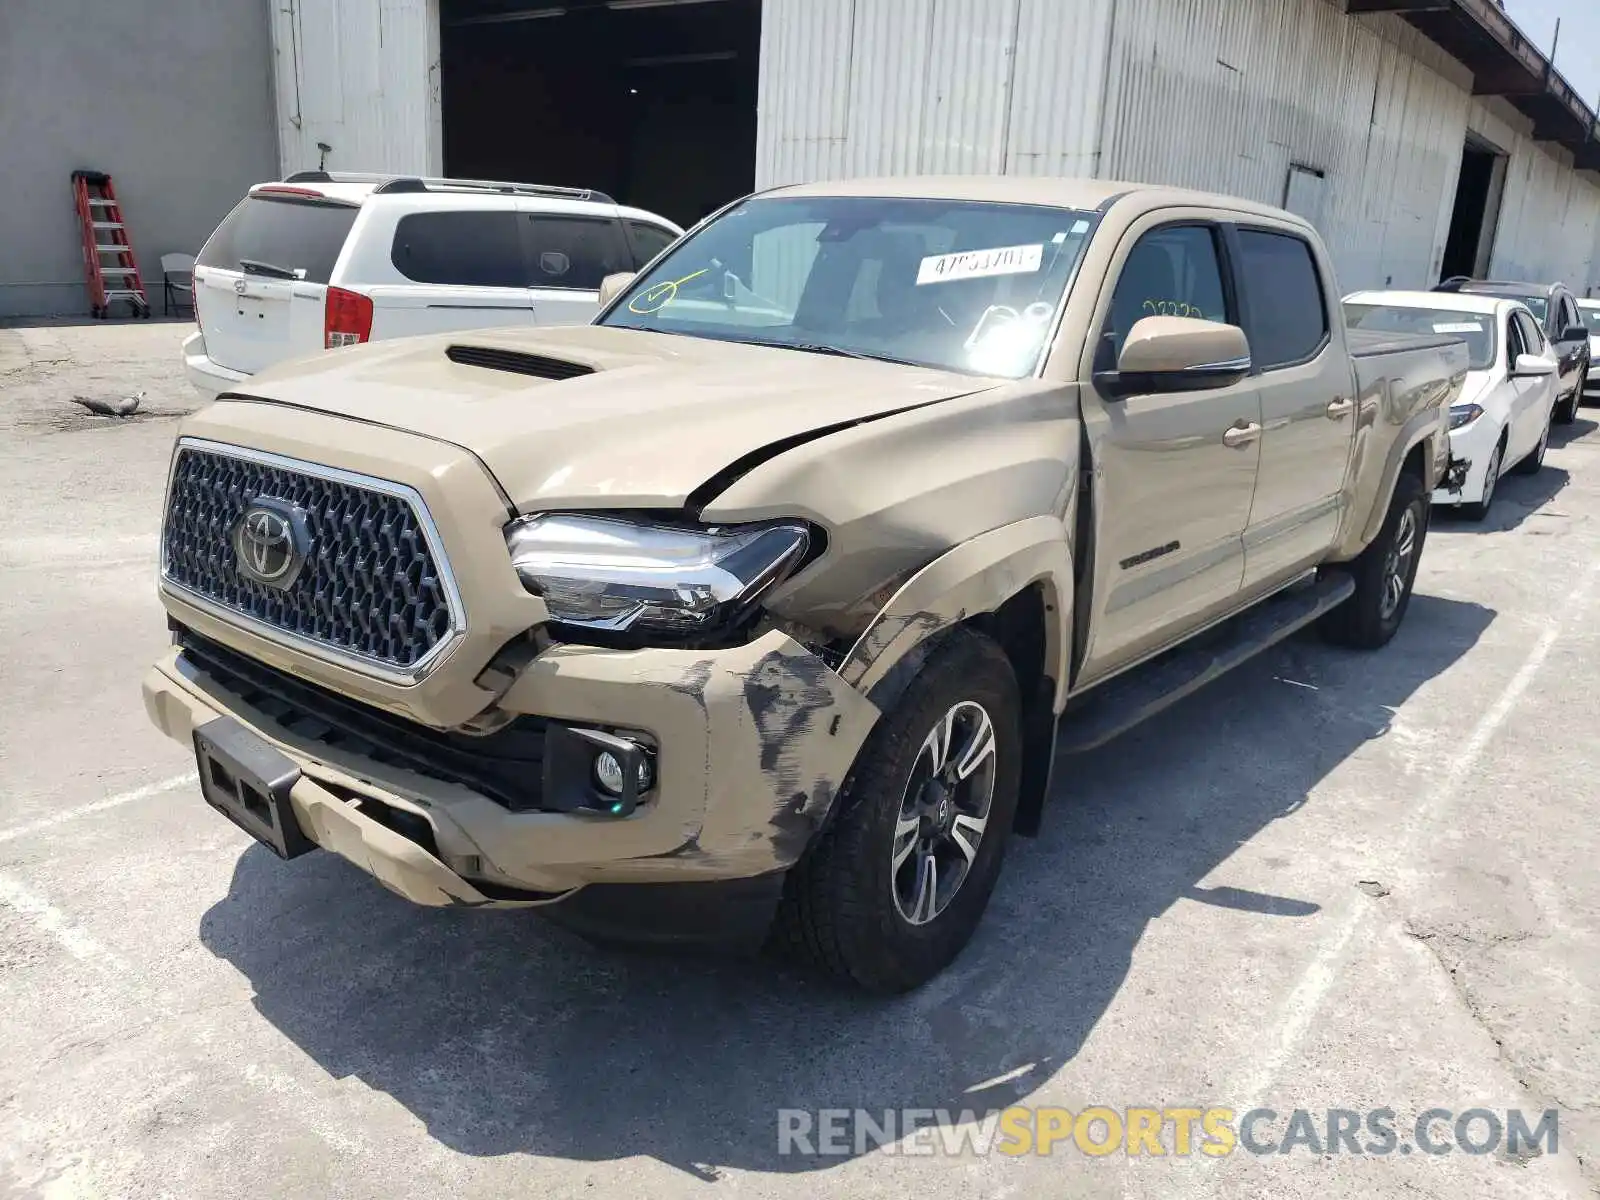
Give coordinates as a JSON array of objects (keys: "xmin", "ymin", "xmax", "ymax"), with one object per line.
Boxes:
[{"xmin": 440, "ymin": 0, "xmax": 762, "ymax": 226}]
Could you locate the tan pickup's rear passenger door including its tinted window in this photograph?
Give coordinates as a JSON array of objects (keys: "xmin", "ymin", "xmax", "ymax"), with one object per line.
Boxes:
[{"xmin": 1232, "ymin": 227, "xmax": 1355, "ymax": 589}]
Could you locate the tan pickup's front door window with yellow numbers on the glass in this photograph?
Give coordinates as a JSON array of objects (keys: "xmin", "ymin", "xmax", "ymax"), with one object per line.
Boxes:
[{"xmin": 1104, "ymin": 226, "xmax": 1229, "ymax": 362}]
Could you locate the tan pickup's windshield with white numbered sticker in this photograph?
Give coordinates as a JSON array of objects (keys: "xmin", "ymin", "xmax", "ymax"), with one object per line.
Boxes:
[{"xmin": 598, "ymin": 197, "xmax": 1096, "ymax": 379}]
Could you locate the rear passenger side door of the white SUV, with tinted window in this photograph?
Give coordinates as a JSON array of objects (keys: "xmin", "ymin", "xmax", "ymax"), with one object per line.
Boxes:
[{"xmin": 517, "ymin": 200, "xmax": 634, "ymax": 325}]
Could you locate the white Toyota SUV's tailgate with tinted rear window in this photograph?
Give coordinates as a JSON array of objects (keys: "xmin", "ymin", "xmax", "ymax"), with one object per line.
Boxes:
[{"xmin": 195, "ymin": 187, "xmax": 360, "ymax": 374}]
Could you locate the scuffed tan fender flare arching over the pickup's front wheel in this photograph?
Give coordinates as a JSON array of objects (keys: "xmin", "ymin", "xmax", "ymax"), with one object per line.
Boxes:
[{"xmin": 838, "ymin": 517, "xmax": 1072, "ymax": 712}]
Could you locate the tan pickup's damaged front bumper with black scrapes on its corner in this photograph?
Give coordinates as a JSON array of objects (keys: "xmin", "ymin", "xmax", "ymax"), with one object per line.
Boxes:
[{"xmin": 144, "ymin": 632, "xmax": 878, "ymax": 906}]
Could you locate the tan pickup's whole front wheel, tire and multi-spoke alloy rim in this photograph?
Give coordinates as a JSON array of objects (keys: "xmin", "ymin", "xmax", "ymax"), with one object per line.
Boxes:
[{"xmin": 774, "ymin": 630, "xmax": 1022, "ymax": 994}]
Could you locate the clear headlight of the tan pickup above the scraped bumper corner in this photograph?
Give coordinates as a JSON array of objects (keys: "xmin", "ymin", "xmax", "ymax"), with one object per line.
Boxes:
[{"xmin": 506, "ymin": 512, "xmax": 811, "ymax": 634}]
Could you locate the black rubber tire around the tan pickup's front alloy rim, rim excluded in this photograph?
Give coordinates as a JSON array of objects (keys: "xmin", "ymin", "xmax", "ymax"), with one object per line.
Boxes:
[{"xmin": 773, "ymin": 630, "xmax": 1022, "ymax": 995}]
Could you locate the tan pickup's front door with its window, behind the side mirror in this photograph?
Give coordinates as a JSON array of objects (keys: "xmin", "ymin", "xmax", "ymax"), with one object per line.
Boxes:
[{"xmin": 1078, "ymin": 213, "xmax": 1261, "ymax": 683}]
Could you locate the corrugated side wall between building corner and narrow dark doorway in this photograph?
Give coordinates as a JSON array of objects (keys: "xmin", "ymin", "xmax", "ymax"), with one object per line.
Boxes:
[{"xmin": 1104, "ymin": 0, "xmax": 1470, "ymax": 290}]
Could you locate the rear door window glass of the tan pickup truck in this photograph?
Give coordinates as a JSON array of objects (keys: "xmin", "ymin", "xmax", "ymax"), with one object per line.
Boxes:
[{"xmin": 1238, "ymin": 229, "xmax": 1328, "ymax": 371}]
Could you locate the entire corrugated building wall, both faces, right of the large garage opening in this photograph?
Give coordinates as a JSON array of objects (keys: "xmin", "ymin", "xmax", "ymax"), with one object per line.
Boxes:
[{"xmin": 757, "ymin": 0, "xmax": 1600, "ymax": 299}]
